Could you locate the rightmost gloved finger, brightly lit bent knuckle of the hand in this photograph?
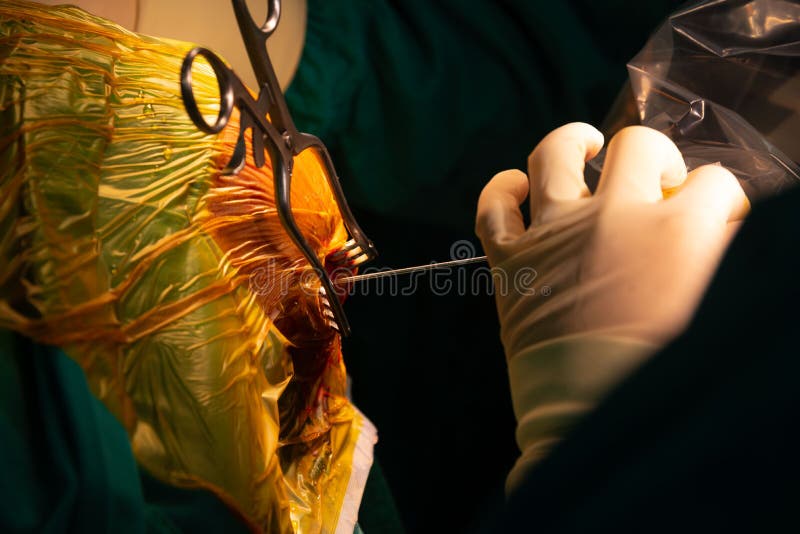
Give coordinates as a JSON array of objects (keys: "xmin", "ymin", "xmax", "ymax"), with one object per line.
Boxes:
[{"xmin": 669, "ymin": 165, "xmax": 750, "ymax": 223}]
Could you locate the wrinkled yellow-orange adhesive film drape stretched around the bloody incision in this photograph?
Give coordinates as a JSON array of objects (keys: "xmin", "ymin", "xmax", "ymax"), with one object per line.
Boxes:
[{"xmin": 0, "ymin": 1, "xmax": 374, "ymax": 532}]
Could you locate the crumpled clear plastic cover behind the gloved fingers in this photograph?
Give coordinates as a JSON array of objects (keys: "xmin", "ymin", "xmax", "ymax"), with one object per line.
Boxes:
[{"xmin": 587, "ymin": 0, "xmax": 800, "ymax": 200}]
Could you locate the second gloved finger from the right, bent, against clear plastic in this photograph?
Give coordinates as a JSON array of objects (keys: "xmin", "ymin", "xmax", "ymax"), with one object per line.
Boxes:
[{"xmin": 596, "ymin": 126, "xmax": 686, "ymax": 202}]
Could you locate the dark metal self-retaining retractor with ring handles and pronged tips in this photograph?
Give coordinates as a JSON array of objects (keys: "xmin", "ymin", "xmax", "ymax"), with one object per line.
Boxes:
[{"xmin": 181, "ymin": 0, "xmax": 377, "ymax": 336}]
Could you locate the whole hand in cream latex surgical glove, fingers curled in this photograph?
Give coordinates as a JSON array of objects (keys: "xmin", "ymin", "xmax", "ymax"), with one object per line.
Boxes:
[{"xmin": 476, "ymin": 123, "xmax": 749, "ymax": 487}]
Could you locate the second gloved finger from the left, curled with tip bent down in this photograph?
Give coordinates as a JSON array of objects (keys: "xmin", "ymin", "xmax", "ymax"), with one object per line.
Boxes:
[{"xmin": 528, "ymin": 122, "xmax": 603, "ymax": 223}]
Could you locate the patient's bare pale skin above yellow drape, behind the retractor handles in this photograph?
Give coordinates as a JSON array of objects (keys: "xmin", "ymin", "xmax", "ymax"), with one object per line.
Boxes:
[{"xmin": 34, "ymin": 0, "xmax": 307, "ymax": 90}]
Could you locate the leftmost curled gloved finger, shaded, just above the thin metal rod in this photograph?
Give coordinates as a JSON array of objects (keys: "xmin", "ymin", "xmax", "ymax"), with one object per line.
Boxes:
[{"xmin": 475, "ymin": 169, "xmax": 528, "ymax": 251}]
